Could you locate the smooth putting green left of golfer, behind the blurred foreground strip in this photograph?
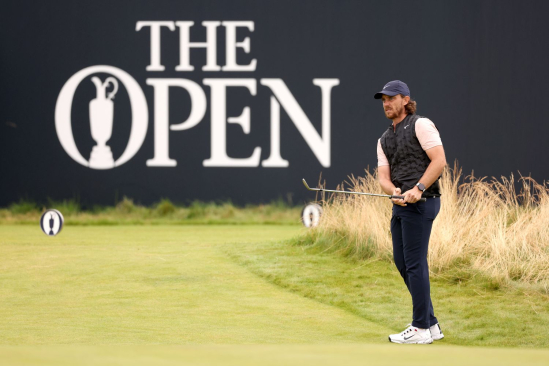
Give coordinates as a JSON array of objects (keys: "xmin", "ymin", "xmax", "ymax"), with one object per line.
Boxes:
[{"xmin": 0, "ymin": 226, "xmax": 388, "ymax": 345}]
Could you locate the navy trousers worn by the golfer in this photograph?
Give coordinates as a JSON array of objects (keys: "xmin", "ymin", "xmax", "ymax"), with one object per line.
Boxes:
[{"xmin": 391, "ymin": 197, "xmax": 440, "ymax": 328}]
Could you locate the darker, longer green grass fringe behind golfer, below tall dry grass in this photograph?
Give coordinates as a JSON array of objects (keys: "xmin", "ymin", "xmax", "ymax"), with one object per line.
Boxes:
[{"xmin": 225, "ymin": 233, "xmax": 549, "ymax": 348}]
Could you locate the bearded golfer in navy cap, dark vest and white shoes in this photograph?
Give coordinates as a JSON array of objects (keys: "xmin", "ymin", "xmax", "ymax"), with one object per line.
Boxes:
[{"xmin": 374, "ymin": 80, "xmax": 446, "ymax": 344}]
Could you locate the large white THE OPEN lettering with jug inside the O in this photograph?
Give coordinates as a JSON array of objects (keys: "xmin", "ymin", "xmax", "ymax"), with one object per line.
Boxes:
[{"xmin": 55, "ymin": 21, "xmax": 339, "ymax": 169}]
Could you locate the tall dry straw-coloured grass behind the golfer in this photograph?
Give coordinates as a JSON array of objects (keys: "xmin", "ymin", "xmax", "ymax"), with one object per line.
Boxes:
[{"xmin": 304, "ymin": 165, "xmax": 549, "ymax": 284}]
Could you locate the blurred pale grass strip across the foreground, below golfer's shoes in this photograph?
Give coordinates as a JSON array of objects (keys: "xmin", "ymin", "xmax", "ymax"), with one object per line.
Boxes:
[{"xmin": 0, "ymin": 343, "xmax": 549, "ymax": 366}]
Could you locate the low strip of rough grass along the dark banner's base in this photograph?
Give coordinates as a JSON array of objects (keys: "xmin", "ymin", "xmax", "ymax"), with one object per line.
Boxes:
[{"xmin": 0, "ymin": 197, "xmax": 302, "ymax": 225}]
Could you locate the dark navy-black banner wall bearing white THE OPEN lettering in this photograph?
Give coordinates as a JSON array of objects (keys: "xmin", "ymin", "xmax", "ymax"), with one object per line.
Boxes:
[{"xmin": 0, "ymin": 0, "xmax": 549, "ymax": 206}]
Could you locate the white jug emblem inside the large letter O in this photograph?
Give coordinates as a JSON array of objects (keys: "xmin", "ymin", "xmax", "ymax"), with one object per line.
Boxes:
[{"xmin": 90, "ymin": 76, "xmax": 118, "ymax": 169}]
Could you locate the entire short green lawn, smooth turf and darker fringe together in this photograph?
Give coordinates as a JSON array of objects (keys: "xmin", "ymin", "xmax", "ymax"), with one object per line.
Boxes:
[{"xmin": 0, "ymin": 225, "xmax": 549, "ymax": 365}]
